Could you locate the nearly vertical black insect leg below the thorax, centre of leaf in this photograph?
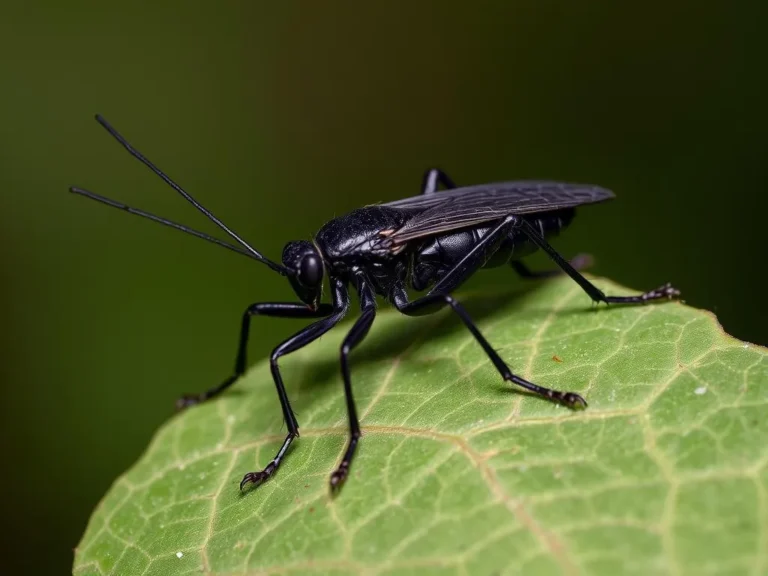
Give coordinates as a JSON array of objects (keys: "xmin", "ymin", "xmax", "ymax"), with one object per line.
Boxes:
[{"xmin": 331, "ymin": 274, "xmax": 376, "ymax": 491}]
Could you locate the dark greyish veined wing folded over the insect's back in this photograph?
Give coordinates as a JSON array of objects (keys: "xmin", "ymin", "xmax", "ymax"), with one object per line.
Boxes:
[{"xmin": 384, "ymin": 181, "xmax": 614, "ymax": 246}]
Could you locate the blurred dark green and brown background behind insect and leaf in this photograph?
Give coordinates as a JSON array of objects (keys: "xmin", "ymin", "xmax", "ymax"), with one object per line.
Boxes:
[{"xmin": 0, "ymin": 0, "xmax": 768, "ymax": 574}]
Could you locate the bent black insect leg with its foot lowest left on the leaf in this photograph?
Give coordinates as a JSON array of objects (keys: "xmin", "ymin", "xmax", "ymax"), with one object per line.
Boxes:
[{"xmin": 240, "ymin": 280, "xmax": 349, "ymax": 490}]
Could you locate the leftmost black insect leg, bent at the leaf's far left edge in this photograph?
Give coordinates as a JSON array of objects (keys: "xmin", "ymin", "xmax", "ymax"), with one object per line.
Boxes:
[{"xmin": 176, "ymin": 302, "xmax": 333, "ymax": 410}]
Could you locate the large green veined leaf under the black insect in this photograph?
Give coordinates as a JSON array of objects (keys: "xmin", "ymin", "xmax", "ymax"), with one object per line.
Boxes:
[{"xmin": 74, "ymin": 278, "xmax": 768, "ymax": 575}]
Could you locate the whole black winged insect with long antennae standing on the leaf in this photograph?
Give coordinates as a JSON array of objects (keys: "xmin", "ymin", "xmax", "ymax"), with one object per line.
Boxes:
[{"xmin": 70, "ymin": 115, "xmax": 680, "ymax": 490}]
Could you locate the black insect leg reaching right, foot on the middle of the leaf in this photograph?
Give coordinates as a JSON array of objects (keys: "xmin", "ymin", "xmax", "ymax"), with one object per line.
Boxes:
[{"xmin": 392, "ymin": 284, "xmax": 587, "ymax": 409}]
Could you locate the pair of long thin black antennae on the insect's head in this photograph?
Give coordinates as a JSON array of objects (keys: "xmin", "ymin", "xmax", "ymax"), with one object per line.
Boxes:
[{"xmin": 77, "ymin": 114, "xmax": 292, "ymax": 276}]
